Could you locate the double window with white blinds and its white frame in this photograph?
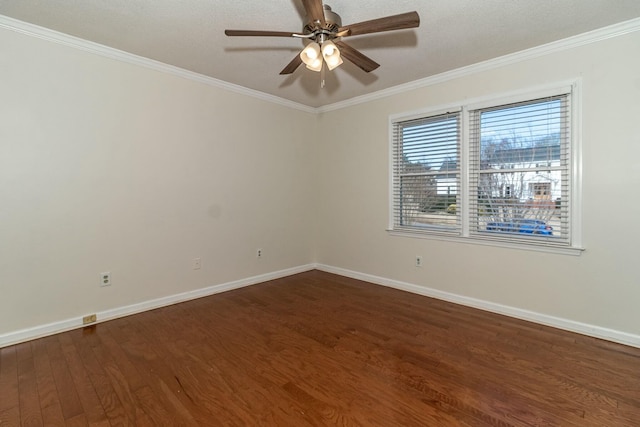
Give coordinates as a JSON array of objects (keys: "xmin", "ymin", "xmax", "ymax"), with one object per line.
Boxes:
[{"xmin": 391, "ymin": 86, "xmax": 579, "ymax": 254}]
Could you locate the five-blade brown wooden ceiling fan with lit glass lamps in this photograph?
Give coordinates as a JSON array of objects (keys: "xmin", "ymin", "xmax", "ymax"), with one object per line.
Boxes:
[{"xmin": 224, "ymin": 0, "xmax": 420, "ymax": 77}]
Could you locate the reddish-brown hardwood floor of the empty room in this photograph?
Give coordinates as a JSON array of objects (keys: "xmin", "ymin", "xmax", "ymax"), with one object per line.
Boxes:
[{"xmin": 0, "ymin": 271, "xmax": 640, "ymax": 427}]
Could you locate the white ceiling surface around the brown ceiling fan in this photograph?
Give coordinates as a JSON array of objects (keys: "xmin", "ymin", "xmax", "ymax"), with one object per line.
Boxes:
[{"xmin": 0, "ymin": 0, "xmax": 640, "ymax": 107}]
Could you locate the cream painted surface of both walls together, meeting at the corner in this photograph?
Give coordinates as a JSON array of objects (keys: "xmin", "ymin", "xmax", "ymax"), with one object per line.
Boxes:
[{"xmin": 0, "ymin": 19, "xmax": 640, "ymax": 346}]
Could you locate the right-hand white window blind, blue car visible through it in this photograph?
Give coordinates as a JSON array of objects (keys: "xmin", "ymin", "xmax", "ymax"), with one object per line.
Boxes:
[{"xmin": 469, "ymin": 94, "xmax": 571, "ymax": 245}]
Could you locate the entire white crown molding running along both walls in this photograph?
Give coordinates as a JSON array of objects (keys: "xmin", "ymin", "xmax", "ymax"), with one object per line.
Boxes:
[{"xmin": 0, "ymin": 15, "xmax": 640, "ymax": 114}]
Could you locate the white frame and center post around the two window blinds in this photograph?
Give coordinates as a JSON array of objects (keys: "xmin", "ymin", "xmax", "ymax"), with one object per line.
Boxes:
[{"xmin": 387, "ymin": 79, "xmax": 584, "ymax": 255}]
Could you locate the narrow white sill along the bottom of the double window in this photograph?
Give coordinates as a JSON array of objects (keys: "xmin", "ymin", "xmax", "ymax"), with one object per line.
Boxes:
[{"xmin": 387, "ymin": 229, "xmax": 584, "ymax": 256}]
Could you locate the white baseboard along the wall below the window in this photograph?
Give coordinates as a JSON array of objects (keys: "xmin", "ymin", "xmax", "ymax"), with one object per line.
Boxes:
[{"xmin": 316, "ymin": 264, "xmax": 640, "ymax": 348}]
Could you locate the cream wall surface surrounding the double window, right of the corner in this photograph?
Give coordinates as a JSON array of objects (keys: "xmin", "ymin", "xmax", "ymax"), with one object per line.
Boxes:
[{"xmin": 317, "ymin": 32, "xmax": 640, "ymax": 344}]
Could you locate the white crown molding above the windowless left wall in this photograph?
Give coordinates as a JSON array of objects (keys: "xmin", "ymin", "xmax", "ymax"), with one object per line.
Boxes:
[{"xmin": 0, "ymin": 15, "xmax": 317, "ymax": 113}]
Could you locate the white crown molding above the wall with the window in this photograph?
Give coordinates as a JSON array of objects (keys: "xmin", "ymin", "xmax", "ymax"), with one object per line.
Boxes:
[{"xmin": 316, "ymin": 18, "xmax": 640, "ymax": 113}]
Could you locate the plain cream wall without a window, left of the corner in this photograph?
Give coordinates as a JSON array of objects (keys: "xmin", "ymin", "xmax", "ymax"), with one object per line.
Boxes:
[{"xmin": 0, "ymin": 29, "xmax": 317, "ymax": 344}]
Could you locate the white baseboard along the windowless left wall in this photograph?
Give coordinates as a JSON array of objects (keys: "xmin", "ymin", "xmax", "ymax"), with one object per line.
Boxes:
[{"xmin": 0, "ymin": 264, "xmax": 316, "ymax": 348}]
